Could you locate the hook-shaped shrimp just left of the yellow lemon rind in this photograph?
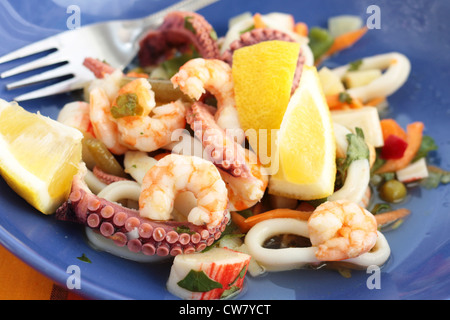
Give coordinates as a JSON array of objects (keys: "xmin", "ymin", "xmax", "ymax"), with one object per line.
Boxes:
[{"xmin": 171, "ymin": 58, "xmax": 245, "ymax": 144}]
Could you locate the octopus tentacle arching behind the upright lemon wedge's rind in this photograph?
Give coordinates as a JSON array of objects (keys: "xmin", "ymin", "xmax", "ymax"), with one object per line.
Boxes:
[{"xmin": 221, "ymin": 28, "xmax": 305, "ymax": 93}]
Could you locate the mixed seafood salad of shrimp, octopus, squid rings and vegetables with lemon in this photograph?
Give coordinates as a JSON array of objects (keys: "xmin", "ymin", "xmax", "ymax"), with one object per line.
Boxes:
[{"xmin": 0, "ymin": 11, "xmax": 449, "ymax": 300}]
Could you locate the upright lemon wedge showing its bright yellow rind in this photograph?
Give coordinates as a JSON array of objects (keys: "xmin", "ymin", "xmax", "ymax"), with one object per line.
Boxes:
[{"xmin": 232, "ymin": 40, "xmax": 300, "ymax": 165}]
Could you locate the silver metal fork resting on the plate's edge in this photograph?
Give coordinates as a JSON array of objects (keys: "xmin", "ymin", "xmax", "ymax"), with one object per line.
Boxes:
[{"xmin": 0, "ymin": 0, "xmax": 219, "ymax": 101}]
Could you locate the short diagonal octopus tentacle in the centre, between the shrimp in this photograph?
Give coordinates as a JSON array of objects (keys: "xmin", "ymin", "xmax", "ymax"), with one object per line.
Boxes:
[{"xmin": 186, "ymin": 101, "xmax": 251, "ymax": 178}]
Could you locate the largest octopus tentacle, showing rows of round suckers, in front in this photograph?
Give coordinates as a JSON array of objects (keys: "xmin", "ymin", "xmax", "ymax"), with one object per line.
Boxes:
[{"xmin": 55, "ymin": 169, "xmax": 229, "ymax": 256}]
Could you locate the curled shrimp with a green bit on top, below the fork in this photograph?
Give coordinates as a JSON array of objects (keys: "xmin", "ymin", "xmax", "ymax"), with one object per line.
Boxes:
[{"xmin": 90, "ymin": 78, "xmax": 186, "ymax": 155}]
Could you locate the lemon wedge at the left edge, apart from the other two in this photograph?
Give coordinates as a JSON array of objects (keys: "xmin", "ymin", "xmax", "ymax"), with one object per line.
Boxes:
[{"xmin": 0, "ymin": 99, "xmax": 83, "ymax": 214}]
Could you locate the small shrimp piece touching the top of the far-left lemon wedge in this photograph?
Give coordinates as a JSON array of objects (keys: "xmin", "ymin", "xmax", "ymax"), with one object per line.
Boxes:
[{"xmin": 57, "ymin": 101, "xmax": 94, "ymax": 134}]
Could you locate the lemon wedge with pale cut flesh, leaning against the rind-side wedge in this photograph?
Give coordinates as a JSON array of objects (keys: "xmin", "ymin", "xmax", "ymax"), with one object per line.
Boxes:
[{"xmin": 269, "ymin": 66, "xmax": 336, "ymax": 200}]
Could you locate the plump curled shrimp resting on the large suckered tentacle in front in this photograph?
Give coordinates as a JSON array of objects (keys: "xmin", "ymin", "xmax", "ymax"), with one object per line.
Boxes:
[{"xmin": 139, "ymin": 154, "xmax": 228, "ymax": 228}]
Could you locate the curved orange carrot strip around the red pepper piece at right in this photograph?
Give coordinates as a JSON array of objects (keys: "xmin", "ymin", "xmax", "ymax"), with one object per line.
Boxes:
[{"xmin": 376, "ymin": 121, "xmax": 424, "ymax": 173}]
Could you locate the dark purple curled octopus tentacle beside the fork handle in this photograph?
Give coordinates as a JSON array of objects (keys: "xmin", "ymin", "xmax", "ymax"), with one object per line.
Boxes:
[{"xmin": 138, "ymin": 11, "xmax": 220, "ymax": 67}]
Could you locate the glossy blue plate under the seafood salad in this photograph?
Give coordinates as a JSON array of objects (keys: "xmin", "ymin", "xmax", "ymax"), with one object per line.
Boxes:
[{"xmin": 0, "ymin": 0, "xmax": 450, "ymax": 300}]
